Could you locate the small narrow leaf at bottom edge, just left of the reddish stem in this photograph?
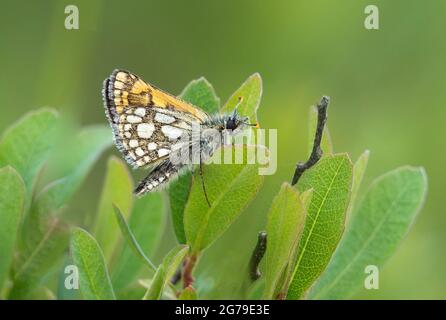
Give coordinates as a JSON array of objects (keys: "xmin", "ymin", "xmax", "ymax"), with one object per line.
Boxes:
[{"xmin": 144, "ymin": 245, "xmax": 189, "ymax": 300}]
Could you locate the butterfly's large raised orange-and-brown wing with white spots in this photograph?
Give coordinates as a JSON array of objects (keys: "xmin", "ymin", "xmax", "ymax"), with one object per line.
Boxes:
[{"xmin": 103, "ymin": 70, "xmax": 208, "ymax": 168}]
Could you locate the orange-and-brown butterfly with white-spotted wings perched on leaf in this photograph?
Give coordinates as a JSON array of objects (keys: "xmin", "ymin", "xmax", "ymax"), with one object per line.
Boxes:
[{"xmin": 102, "ymin": 70, "xmax": 253, "ymax": 204}]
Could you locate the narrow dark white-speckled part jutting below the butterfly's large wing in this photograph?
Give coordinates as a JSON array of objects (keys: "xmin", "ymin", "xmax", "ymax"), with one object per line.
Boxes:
[{"xmin": 133, "ymin": 160, "xmax": 181, "ymax": 197}]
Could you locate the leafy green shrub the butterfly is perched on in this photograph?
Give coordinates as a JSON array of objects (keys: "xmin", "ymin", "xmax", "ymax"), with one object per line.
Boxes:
[{"xmin": 0, "ymin": 74, "xmax": 427, "ymax": 299}]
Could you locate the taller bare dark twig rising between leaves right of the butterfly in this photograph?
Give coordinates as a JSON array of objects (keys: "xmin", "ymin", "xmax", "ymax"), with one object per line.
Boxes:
[{"xmin": 291, "ymin": 96, "xmax": 330, "ymax": 186}]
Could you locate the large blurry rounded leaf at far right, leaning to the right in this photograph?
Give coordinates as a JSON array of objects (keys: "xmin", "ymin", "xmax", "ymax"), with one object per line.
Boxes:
[{"xmin": 309, "ymin": 167, "xmax": 427, "ymax": 299}]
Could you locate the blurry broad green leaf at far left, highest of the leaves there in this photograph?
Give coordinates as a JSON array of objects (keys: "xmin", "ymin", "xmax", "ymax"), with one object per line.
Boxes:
[{"xmin": 0, "ymin": 109, "xmax": 58, "ymax": 198}]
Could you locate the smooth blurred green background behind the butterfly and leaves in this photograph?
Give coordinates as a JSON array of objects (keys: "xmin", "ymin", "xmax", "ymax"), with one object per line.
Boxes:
[{"xmin": 0, "ymin": 0, "xmax": 446, "ymax": 299}]
